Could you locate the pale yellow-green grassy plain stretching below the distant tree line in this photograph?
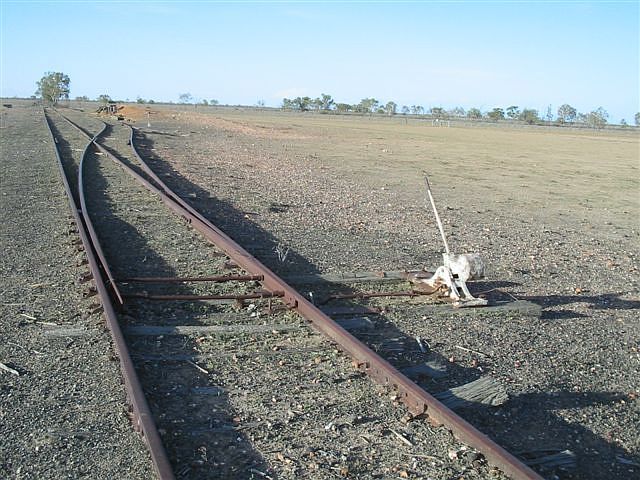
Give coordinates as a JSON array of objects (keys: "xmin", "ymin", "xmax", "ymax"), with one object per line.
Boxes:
[{"xmin": 166, "ymin": 109, "xmax": 640, "ymax": 238}]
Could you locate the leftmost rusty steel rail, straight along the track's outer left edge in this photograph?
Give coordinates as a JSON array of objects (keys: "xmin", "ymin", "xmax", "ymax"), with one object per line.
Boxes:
[{"xmin": 43, "ymin": 110, "xmax": 175, "ymax": 480}]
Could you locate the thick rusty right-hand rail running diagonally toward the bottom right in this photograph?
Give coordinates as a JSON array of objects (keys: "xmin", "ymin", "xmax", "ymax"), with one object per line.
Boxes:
[{"xmin": 62, "ymin": 111, "xmax": 542, "ymax": 480}]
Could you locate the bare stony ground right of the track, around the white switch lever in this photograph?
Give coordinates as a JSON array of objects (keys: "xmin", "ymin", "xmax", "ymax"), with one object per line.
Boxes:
[{"xmin": 126, "ymin": 107, "xmax": 640, "ymax": 479}]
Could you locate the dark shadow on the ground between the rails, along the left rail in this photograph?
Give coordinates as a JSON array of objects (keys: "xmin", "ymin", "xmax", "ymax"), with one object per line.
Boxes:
[{"xmin": 81, "ymin": 127, "xmax": 275, "ymax": 479}]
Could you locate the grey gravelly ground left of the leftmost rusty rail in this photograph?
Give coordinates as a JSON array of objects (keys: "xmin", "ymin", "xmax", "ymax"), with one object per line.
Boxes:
[{"xmin": 0, "ymin": 101, "xmax": 153, "ymax": 480}]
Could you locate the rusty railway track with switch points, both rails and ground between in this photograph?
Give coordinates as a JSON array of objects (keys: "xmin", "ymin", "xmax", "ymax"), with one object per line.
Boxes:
[{"xmin": 45, "ymin": 111, "xmax": 541, "ymax": 479}]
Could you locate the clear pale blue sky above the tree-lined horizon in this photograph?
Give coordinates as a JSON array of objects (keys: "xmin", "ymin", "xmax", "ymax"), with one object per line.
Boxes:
[{"xmin": 0, "ymin": 0, "xmax": 640, "ymax": 123}]
